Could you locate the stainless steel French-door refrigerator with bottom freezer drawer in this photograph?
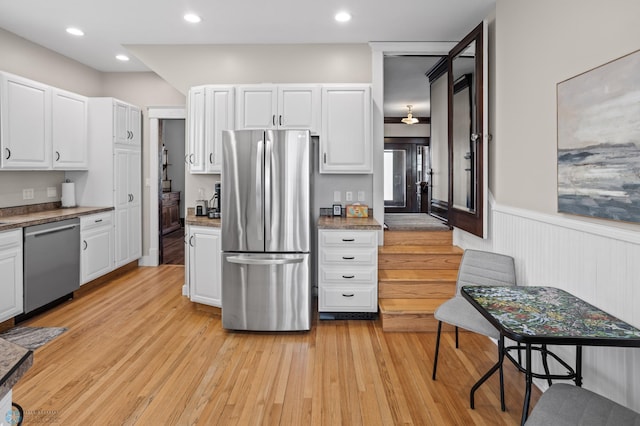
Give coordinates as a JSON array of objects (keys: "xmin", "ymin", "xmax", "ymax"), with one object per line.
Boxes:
[{"xmin": 220, "ymin": 130, "xmax": 311, "ymax": 331}]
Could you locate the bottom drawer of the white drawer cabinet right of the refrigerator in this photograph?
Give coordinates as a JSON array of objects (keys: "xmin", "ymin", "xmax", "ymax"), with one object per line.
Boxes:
[{"xmin": 319, "ymin": 286, "xmax": 378, "ymax": 312}]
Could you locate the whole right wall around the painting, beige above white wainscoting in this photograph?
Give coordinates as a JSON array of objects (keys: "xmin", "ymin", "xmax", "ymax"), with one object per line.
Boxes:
[{"xmin": 454, "ymin": 0, "xmax": 640, "ymax": 411}]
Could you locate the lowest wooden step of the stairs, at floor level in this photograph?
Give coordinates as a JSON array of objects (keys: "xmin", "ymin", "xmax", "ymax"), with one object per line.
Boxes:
[{"xmin": 378, "ymin": 299, "xmax": 453, "ymax": 332}]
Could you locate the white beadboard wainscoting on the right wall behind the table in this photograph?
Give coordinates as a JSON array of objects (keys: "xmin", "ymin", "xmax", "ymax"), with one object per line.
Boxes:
[{"xmin": 454, "ymin": 203, "xmax": 640, "ymax": 411}]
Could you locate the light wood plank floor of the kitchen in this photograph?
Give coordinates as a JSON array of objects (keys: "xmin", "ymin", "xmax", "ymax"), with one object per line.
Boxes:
[{"xmin": 14, "ymin": 265, "xmax": 539, "ymax": 425}]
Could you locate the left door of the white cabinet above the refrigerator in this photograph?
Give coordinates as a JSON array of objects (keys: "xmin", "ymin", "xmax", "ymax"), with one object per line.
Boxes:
[{"xmin": 236, "ymin": 86, "xmax": 278, "ymax": 129}]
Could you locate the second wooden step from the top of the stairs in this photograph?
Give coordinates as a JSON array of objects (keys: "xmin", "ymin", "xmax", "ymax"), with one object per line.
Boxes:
[{"xmin": 378, "ymin": 245, "xmax": 463, "ymax": 270}]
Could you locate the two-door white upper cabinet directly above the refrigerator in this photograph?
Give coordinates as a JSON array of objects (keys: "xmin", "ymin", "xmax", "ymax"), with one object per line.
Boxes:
[{"xmin": 236, "ymin": 84, "xmax": 320, "ymax": 134}]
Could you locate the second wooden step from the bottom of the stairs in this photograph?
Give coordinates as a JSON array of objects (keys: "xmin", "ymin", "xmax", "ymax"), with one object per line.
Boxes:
[{"xmin": 378, "ymin": 269, "xmax": 458, "ymax": 299}]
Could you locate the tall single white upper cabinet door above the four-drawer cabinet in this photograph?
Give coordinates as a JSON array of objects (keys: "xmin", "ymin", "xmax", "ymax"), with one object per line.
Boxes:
[{"xmin": 319, "ymin": 85, "xmax": 373, "ymax": 173}]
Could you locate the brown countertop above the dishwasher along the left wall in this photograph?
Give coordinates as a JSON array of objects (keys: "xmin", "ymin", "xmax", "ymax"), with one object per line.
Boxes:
[{"xmin": 0, "ymin": 206, "xmax": 113, "ymax": 232}]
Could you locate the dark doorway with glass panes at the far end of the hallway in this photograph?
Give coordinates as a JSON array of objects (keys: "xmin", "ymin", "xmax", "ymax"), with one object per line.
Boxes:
[{"xmin": 384, "ymin": 137, "xmax": 430, "ymax": 213}]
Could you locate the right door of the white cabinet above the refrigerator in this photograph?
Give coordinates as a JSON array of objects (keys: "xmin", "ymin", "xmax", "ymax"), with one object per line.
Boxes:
[{"xmin": 277, "ymin": 85, "xmax": 320, "ymax": 134}]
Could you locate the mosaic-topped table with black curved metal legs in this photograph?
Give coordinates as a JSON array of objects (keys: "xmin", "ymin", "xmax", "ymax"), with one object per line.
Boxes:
[{"xmin": 461, "ymin": 286, "xmax": 640, "ymax": 424}]
